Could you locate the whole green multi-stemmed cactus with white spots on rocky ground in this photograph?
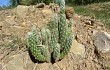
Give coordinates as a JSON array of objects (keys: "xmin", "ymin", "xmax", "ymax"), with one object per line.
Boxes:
[{"xmin": 28, "ymin": 0, "xmax": 73, "ymax": 62}]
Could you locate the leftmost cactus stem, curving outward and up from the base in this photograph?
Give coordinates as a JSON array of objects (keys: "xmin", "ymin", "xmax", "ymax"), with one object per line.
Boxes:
[{"xmin": 28, "ymin": 32, "xmax": 46, "ymax": 61}]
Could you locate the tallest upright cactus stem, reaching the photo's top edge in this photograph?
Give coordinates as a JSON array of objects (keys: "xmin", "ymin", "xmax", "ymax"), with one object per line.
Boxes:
[{"xmin": 59, "ymin": 0, "xmax": 66, "ymax": 49}]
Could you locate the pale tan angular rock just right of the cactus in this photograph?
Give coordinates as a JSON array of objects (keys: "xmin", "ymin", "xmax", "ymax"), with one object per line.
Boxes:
[{"xmin": 70, "ymin": 40, "xmax": 85, "ymax": 56}]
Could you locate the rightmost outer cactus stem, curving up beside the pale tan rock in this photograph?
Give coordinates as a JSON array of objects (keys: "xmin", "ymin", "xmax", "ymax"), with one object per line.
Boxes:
[{"xmin": 59, "ymin": 34, "xmax": 73, "ymax": 60}]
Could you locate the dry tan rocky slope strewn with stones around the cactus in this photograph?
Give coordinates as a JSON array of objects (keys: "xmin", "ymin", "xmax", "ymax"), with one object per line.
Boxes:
[{"xmin": 0, "ymin": 5, "xmax": 110, "ymax": 70}]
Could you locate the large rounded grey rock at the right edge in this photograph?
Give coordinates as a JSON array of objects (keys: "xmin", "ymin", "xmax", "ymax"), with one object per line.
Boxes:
[{"xmin": 93, "ymin": 31, "xmax": 110, "ymax": 53}]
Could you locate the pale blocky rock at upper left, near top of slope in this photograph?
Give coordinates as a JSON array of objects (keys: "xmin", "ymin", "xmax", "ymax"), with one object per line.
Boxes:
[{"xmin": 16, "ymin": 5, "xmax": 29, "ymax": 18}]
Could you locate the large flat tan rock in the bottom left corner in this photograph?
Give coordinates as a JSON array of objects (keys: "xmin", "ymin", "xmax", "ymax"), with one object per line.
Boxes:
[{"xmin": 2, "ymin": 52, "xmax": 35, "ymax": 70}]
